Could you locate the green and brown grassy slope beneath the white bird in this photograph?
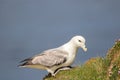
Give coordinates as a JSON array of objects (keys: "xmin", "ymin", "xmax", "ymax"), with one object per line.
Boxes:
[{"xmin": 45, "ymin": 40, "xmax": 120, "ymax": 80}]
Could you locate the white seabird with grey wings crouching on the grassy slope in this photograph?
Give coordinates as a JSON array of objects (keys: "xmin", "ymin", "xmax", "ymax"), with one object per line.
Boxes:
[{"xmin": 19, "ymin": 35, "xmax": 87, "ymax": 76}]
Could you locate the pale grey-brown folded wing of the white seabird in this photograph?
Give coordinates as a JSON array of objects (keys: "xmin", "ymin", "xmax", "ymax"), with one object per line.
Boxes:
[{"xmin": 32, "ymin": 50, "xmax": 68, "ymax": 67}]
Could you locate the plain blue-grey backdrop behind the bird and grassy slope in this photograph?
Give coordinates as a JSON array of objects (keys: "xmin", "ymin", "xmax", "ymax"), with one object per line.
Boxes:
[{"xmin": 0, "ymin": 0, "xmax": 120, "ymax": 80}]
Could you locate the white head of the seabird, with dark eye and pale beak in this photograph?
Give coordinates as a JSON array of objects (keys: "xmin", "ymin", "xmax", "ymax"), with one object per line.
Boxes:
[{"xmin": 70, "ymin": 36, "xmax": 87, "ymax": 51}]
